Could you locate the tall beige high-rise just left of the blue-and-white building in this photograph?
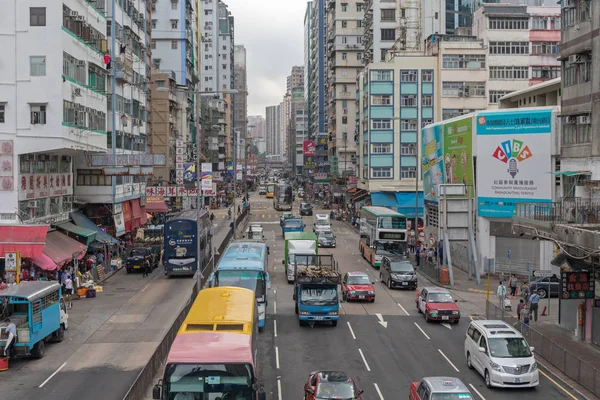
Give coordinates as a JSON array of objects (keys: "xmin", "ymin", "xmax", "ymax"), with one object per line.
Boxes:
[{"xmin": 327, "ymin": 0, "xmax": 364, "ymax": 177}]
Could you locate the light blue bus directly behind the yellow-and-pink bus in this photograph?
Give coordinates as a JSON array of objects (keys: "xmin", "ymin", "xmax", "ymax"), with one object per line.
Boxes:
[{"xmin": 208, "ymin": 240, "xmax": 271, "ymax": 328}]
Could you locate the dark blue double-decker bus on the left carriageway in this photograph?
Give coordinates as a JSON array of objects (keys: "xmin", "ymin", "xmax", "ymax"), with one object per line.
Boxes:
[{"xmin": 162, "ymin": 210, "xmax": 212, "ymax": 276}]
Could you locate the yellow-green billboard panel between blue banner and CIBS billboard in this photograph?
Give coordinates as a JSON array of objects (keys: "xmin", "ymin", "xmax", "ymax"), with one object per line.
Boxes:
[{"xmin": 443, "ymin": 115, "xmax": 473, "ymax": 190}]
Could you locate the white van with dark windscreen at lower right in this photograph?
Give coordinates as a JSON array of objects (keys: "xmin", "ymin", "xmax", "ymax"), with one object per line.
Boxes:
[{"xmin": 465, "ymin": 320, "xmax": 540, "ymax": 388}]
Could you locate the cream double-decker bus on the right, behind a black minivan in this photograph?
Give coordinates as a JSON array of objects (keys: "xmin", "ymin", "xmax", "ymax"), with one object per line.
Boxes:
[{"xmin": 359, "ymin": 207, "xmax": 407, "ymax": 268}]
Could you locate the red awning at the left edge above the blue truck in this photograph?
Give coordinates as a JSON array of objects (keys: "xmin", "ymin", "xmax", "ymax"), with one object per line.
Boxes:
[{"xmin": 0, "ymin": 225, "xmax": 48, "ymax": 258}]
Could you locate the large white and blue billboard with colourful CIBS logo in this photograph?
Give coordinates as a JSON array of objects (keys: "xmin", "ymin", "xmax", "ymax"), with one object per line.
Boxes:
[{"xmin": 476, "ymin": 110, "xmax": 553, "ymax": 218}]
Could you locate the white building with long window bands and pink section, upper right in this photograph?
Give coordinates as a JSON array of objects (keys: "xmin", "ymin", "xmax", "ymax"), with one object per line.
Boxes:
[{"xmin": 474, "ymin": 1, "xmax": 561, "ymax": 108}]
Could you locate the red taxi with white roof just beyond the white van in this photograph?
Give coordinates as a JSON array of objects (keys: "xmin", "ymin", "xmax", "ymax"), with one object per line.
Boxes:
[{"xmin": 415, "ymin": 287, "xmax": 460, "ymax": 324}]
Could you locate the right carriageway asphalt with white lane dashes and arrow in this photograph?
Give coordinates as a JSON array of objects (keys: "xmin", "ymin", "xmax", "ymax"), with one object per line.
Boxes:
[{"xmin": 251, "ymin": 195, "xmax": 581, "ymax": 400}]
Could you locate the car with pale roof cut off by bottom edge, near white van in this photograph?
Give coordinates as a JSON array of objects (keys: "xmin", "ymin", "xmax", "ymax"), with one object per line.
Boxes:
[{"xmin": 408, "ymin": 376, "xmax": 473, "ymax": 400}]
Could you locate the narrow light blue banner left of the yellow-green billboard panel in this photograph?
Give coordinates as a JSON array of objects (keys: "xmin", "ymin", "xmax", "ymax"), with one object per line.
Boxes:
[{"xmin": 421, "ymin": 124, "xmax": 444, "ymax": 203}]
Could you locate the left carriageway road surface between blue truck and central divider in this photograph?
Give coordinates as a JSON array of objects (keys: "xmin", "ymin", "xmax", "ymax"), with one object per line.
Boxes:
[{"xmin": 0, "ymin": 216, "xmax": 229, "ymax": 400}]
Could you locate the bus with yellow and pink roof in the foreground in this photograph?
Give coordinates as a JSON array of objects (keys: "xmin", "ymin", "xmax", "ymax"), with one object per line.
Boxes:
[{"xmin": 152, "ymin": 287, "xmax": 266, "ymax": 400}]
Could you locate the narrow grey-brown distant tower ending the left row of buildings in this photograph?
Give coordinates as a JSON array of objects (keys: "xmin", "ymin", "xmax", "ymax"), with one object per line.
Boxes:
[{"xmin": 233, "ymin": 45, "xmax": 248, "ymax": 160}]
